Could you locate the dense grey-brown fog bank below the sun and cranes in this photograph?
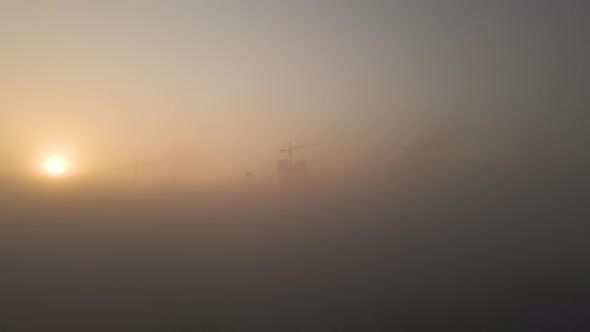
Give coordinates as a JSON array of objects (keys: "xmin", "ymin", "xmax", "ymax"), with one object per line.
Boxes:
[{"xmin": 0, "ymin": 151, "xmax": 590, "ymax": 332}]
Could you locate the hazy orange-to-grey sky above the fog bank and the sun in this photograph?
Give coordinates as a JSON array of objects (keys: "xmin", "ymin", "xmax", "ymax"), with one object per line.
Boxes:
[{"xmin": 0, "ymin": 0, "xmax": 589, "ymax": 182}]
